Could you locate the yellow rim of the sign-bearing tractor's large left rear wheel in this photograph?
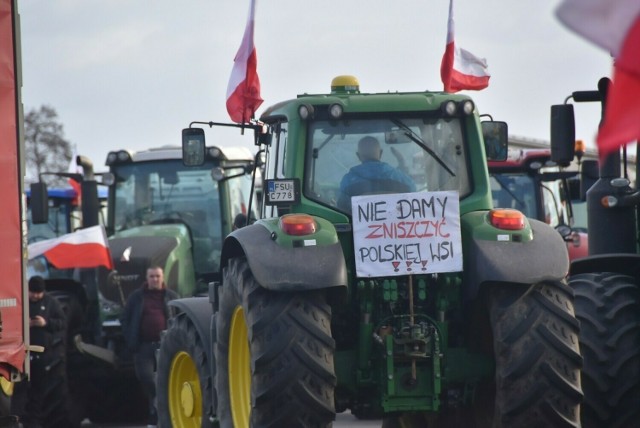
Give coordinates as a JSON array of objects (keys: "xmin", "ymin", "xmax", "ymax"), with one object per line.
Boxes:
[{"xmin": 228, "ymin": 307, "xmax": 251, "ymax": 428}]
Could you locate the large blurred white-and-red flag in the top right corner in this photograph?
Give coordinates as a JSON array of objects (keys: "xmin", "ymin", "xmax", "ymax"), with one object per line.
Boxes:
[{"xmin": 556, "ymin": 0, "xmax": 640, "ymax": 157}]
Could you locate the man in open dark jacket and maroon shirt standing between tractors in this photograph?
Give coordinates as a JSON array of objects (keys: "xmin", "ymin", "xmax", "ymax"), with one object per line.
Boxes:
[{"xmin": 122, "ymin": 266, "xmax": 178, "ymax": 427}]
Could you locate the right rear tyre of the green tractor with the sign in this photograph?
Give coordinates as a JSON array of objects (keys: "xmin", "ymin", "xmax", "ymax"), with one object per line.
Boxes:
[{"xmin": 488, "ymin": 281, "xmax": 583, "ymax": 428}]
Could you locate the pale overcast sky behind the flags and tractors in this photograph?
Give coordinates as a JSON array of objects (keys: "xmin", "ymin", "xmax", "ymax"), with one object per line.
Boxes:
[{"xmin": 18, "ymin": 0, "xmax": 612, "ymax": 176}]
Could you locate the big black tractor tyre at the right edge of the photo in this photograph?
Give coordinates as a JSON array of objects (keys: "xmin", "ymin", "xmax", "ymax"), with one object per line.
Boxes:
[{"xmin": 569, "ymin": 272, "xmax": 640, "ymax": 428}]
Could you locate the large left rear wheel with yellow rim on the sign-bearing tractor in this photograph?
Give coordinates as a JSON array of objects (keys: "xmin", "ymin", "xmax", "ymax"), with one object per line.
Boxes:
[{"xmin": 215, "ymin": 258, "xmax": 336, "ymax": 428}]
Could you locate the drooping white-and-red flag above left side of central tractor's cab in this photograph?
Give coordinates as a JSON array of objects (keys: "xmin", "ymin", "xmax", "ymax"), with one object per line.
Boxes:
[{"xmin": 227, "ymin": 0, "xmax": 263, "ymax": 123}]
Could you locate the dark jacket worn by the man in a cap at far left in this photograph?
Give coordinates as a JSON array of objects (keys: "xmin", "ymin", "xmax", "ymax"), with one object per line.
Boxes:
[{"xmin": 29, "ymin": 293, "xmax": 66, "ymax": 355}]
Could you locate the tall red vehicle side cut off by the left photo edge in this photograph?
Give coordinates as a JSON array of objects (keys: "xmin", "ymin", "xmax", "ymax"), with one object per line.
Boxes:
[{"xmin": 0, "ymin": 0, "xmax": 29, "ymax": 426}]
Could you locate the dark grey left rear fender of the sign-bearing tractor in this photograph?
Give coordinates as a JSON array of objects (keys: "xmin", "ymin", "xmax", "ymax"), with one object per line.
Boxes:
[{"xmin": 220, "ymin": 223, "xmax": 347, "ymax": 291}]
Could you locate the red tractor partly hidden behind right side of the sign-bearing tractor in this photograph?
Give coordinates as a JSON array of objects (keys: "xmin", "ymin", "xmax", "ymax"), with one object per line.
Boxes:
[{"xmin": 489, "ymin": 149, "xmax": 589, "ymax": 260}]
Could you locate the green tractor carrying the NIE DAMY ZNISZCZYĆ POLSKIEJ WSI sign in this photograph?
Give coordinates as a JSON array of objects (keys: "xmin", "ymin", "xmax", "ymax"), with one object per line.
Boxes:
[{"xmin": 157, "ymin": 76, "xmax": 582, "ymax": 428}]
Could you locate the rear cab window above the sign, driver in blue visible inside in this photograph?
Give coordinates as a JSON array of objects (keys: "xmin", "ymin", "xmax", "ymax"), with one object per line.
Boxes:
[{"xmin": 305, "ymin": 118, "xmax": 470, "ymax": 212}]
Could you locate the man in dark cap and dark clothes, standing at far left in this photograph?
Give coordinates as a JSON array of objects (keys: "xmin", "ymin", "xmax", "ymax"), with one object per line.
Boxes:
[{"xmin": 11, "ymin": 276, "xmax": 66, "ymax": 428}]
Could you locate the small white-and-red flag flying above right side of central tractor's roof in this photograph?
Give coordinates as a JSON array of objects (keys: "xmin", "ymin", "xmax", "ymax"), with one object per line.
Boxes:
[{"xmin": 440, "ymin": 0, "xmax": 491, "ymax": 93}]
